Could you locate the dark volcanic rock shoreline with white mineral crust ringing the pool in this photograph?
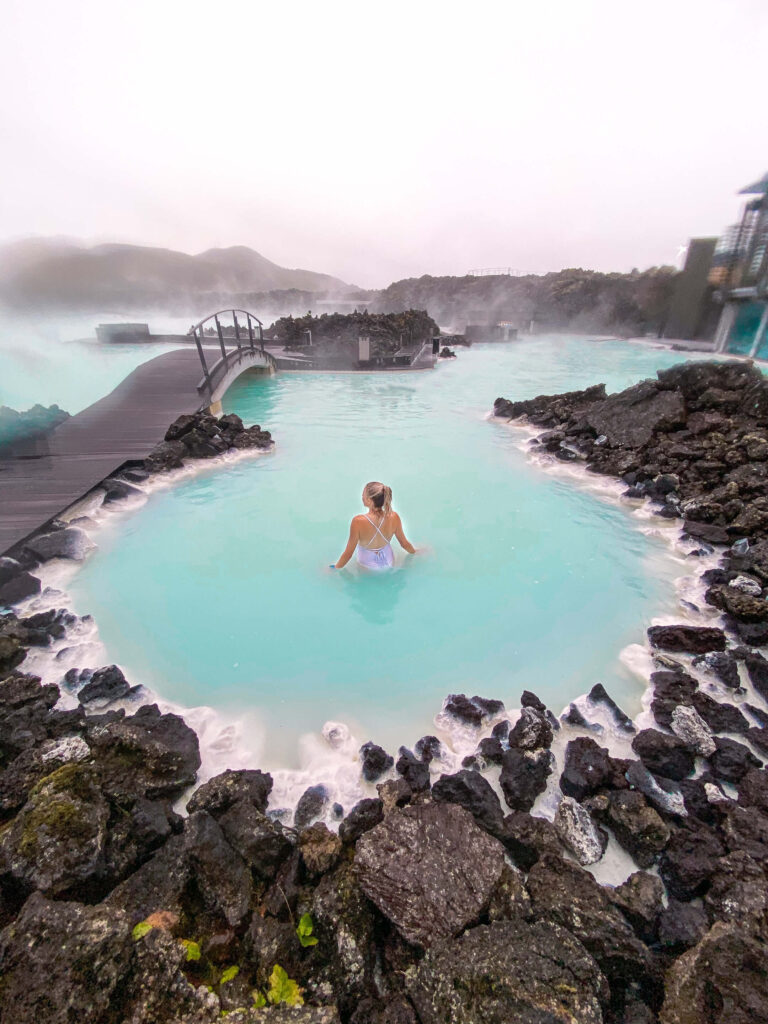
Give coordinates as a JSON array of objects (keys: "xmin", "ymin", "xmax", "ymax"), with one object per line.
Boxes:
[{"xmin": 0, "ymin": 378, "xmax": 768, "ymax": 1024}]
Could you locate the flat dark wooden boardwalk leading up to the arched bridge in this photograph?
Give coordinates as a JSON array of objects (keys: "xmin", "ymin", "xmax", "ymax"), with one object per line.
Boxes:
[{"xmin": 0, "ymin": 349, "xmax": 234, "ymax": 553}]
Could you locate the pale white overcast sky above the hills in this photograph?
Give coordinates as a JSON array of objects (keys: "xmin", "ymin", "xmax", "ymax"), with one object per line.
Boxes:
[{"xmin": 0, "ymin": 0, "xmax": 768, "ymax": 286}]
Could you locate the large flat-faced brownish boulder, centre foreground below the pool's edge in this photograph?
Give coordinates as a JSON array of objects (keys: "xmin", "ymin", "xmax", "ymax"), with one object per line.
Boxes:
[{"xmin": 354, "ymin": 804, "xmax": 504, "ymax": 946}]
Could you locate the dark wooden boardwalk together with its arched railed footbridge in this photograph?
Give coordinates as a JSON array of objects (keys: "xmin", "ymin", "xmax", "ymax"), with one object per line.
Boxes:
[{"xmin": 0, "ymin": 309, "xmax": 274, "ymax": 554}]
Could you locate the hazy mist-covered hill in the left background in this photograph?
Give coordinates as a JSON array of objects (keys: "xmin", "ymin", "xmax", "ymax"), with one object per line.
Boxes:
[{"xmin": 0, "ymin": 239, "xmax": 349, "ymax": 311}]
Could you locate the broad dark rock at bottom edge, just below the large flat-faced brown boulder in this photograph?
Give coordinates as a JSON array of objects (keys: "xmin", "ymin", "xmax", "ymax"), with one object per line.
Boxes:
[{"xmin": 406, "ymin": 922, "xmax": 606, "ymax": 1024}]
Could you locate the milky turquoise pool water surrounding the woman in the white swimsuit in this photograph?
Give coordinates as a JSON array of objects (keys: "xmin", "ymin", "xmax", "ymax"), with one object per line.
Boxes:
[{"xmin": 71, "ymin": 338, "xmax": 696, "ymax": 763}]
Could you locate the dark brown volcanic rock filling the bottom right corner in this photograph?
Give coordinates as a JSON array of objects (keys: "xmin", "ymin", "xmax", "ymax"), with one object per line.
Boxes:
[{"xmin": 659, "ymin": 922, "xmax": 768, "ymax": 1024}]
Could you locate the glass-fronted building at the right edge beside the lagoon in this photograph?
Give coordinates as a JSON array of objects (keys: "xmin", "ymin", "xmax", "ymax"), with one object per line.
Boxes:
[{"xmin": 710, "ymin": 173, "xmax": 768, "ymax": 359}]
